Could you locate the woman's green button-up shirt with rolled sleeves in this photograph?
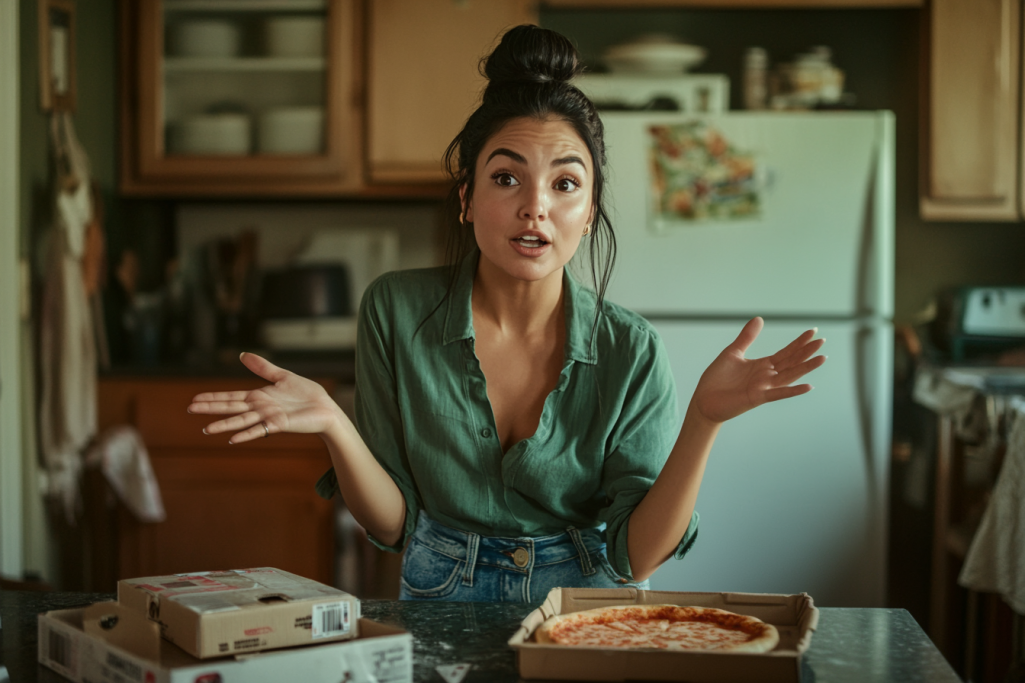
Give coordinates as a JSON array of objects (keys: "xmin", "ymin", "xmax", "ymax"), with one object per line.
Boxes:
[{"xmin": 317, "ymin": 251, "xmax": 698, "ymax": 578}]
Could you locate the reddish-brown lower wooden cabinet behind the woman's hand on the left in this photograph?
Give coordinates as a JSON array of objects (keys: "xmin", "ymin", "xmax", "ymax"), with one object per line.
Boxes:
[{"xmin": 99, "ymin": 378, "xmax": 334, "ymax": 585}]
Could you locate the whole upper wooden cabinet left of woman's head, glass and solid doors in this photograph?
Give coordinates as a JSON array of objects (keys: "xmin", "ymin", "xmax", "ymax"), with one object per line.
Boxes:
[{"xmin": 121, "ymin": 0, "xmax": 537, "ymax": 197}]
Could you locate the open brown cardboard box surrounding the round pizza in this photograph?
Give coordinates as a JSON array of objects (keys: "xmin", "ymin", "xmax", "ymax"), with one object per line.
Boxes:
[{"xmin": 508, "ymin": 588, "xmax": 819, "ymax": 683}]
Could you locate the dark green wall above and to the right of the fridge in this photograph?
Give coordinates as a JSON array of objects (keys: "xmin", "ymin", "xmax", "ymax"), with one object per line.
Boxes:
[{"xmin": 541, "ymin": 9, "xmax": 1025, "ymax": 322}]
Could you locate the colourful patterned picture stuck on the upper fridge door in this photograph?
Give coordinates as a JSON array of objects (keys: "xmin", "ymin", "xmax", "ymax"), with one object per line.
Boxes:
[{"xmin": 649, "ymin": 120, "xmax": 762, "ymax": 230}]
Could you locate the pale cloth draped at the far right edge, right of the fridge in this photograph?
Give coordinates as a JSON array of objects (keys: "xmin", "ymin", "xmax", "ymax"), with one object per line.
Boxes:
[{"xmin": 957, "ymin": 399, "xmax": 1025, "ymax": 614}]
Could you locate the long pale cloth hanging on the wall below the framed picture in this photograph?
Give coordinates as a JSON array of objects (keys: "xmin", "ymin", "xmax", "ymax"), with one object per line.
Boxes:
[{"xmin": 39, "ymin": 113, "xmax": 96, "ymax": 523}]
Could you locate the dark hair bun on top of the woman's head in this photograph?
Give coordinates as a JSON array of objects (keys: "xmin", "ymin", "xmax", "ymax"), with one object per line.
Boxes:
[{"xmin": 484, "ymin": 24, "xmax": 581, "ymax": 85}]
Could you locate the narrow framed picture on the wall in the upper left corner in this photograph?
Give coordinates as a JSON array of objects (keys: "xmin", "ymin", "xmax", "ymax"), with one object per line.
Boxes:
[{"xmin": 38, "ymin": 0, "xmax": 75, "ymax": 112}]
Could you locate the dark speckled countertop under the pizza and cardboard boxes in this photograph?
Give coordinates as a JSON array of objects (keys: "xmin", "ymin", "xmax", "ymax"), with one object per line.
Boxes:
[{"xmin": 0, "ymin": 591, "xmax": 960, "ymax": 683}]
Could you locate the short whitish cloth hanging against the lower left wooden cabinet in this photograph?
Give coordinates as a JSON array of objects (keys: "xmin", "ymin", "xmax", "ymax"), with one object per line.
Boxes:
[{"xmin": 86, "ymin": 425, "xmax": 167, "ymax": 522}]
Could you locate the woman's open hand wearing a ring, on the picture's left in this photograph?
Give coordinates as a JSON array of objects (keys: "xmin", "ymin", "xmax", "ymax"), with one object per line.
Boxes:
[{"xmin": 188, "ymin": 353, "xmax": 347, "ymax": 444}]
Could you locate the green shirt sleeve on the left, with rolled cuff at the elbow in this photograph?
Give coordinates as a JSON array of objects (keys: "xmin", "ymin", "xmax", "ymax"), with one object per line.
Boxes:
[{"xmin": 317, "ymin": 276, "xmax": 423, "ymax": 553}]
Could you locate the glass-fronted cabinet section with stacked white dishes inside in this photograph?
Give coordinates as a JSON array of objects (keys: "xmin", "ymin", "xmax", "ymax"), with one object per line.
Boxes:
[{"xmin": 120, "ymin": 0, "xmax": 363, "ymax": 196}]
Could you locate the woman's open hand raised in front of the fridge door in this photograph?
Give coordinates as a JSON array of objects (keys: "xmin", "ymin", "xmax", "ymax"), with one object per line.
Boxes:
[{"xmin": 691, "ymin": 318, "xmax": 826, "ymax": 423}]
